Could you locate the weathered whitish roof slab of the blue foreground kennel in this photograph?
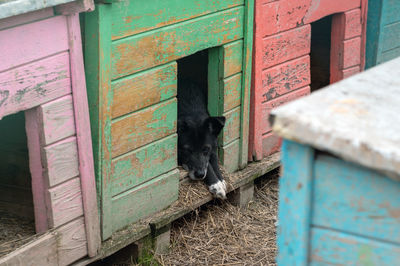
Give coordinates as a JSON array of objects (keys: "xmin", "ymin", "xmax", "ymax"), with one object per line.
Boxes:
[{"xmin": 271, "ymin": 58, "xmax": 400, "ymax": 180}]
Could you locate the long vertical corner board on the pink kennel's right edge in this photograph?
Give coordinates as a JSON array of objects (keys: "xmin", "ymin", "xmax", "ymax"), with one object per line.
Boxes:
[{"xmin": 67, "ymin": 13, "xmax": 101, "ymax": 257}]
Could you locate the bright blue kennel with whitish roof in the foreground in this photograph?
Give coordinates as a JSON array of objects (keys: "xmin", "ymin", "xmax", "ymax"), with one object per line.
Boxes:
[{"xmin": 272, "ymin": 58, "xmax": 400, "ymax": 265}]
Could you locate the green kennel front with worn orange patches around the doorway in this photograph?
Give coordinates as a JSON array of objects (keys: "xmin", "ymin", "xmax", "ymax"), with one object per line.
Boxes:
[{"xmin": 83, "ymin": 0, "xmax": 254, "ymax": 239}]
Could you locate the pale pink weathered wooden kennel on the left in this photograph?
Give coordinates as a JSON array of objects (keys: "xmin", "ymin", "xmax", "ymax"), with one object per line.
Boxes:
[{"xmin": 0, "ymin": 0, "xmax": 100, "ymax": 265}]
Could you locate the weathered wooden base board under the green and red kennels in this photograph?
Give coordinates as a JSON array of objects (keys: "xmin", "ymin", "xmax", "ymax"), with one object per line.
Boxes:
[{"xmin": 73, "ymin": 153, "xmax": 280, "ymax": 266}]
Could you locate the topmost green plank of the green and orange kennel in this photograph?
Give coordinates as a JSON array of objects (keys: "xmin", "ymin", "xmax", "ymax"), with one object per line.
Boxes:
[{"xmin": 112, "ymin": 0, "xmax": 244, "ymax": 40}]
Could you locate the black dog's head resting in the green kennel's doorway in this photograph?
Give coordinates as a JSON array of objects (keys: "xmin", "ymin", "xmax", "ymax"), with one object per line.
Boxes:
[{"xmin": 178, "ymin": 116, "xmax": 225, "ymax": 180}]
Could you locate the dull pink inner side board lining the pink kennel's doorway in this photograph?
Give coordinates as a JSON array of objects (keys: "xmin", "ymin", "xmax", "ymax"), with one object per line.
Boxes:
[{"xmin": 25, "ymin": 108, "xmax": 49, "ymax": 233}]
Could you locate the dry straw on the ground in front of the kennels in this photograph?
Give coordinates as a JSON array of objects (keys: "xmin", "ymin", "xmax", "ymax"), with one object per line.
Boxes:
[{"xmin": 156, "ymin": 171, "xmax": 278, "ymax": 265}]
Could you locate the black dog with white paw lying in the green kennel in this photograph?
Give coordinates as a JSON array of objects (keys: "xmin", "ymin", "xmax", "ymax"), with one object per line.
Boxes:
[{"xmin": 178, "ymin": 79, "xmax": 226, "ymax": 199}]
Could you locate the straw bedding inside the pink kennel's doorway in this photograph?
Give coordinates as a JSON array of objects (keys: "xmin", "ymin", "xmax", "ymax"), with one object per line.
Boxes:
[{"xmin": 0, "ymin": 210, "xmax": 35, "ymax": 257}]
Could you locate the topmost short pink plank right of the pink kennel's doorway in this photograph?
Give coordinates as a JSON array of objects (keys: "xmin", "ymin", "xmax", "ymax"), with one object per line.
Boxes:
[{"xmin": 39, "ymin": 95, "xmax": 75, "ymax": 145}]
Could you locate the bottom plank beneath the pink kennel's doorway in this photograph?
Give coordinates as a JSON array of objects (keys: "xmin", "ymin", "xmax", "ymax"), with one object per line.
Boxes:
[{"xmin": 0, "ymin": 232, "xmax": 58, "ymax": 266}]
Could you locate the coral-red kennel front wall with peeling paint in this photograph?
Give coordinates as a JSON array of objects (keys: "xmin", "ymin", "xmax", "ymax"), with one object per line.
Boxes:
[{"xmin": 249, "ymin": 0, "xmax": 366, "ymax": 160}]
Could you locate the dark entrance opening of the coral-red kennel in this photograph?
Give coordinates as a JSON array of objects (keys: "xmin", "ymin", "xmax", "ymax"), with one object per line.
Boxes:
[{"xmin": 310, "ymin": 15, "xmax": 332, "ymax": 92}]
